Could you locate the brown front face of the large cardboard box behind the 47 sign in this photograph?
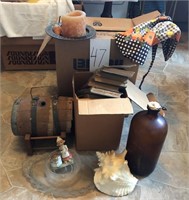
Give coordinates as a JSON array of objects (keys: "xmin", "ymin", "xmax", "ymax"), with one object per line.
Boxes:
[{"xmin": 55, "ymin": 39, "xmax": 138, "ymax": 96}]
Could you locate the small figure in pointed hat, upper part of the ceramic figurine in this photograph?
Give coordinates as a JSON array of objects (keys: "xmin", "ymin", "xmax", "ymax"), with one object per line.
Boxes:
[{"xmin": 56, "ymin": 136, "xmax": 73, "ymax": 164}]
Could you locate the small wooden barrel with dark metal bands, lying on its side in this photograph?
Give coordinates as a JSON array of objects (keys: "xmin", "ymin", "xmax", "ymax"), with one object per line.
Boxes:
[{"xmin": 11, "ymin": 95, "xmax": 73, "ymax": 136}]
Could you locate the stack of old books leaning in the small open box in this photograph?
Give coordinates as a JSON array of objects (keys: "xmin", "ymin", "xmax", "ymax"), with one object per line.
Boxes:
[{"xmin": 77, "ymin": 66, "xmax": 135, "ymax": 98}]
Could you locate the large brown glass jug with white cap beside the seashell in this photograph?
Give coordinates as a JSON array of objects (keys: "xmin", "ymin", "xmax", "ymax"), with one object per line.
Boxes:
[{"xmin": 126, "ymin": 102, "xmax": 168, "ymax": 177}]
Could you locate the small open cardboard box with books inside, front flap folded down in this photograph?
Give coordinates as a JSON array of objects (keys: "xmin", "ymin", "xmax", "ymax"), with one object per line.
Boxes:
[{"xmin": 72, "ymin": 72, "xmax": 133, "ymax": 151}]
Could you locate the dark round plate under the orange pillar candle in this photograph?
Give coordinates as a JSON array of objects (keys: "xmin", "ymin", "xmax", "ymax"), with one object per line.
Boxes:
[{"xmin": 45, "ymin": 24, "xmax": 96, "ymax": 40}]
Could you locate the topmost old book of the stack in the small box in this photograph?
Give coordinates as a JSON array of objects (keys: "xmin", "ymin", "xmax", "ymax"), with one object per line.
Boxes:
[{"xmin": 101, "ymin": 67, "xmax": 135, "ymax": 78}]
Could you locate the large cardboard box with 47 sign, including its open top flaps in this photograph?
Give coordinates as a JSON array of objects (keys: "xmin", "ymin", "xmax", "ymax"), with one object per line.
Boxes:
[{"xmin": 55, "ymin": 11, "xmax": 160, "ymax": 96}]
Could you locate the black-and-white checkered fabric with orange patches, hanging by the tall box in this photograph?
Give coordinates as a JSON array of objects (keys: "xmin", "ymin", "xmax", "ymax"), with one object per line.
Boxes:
[{"xmin": 115, "ymin": 16, "xmax": 181, "ymax": 88}]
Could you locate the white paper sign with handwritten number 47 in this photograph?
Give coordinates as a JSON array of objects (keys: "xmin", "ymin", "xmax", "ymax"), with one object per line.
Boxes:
[{"xmin": 90, "ymin": 39, "xmax": 110, "ymax": 72}]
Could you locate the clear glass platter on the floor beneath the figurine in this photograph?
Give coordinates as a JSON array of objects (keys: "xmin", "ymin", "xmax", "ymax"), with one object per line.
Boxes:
[{"xmin": 23, "ymin": 150, "xmax": 97, "ymax": 198}]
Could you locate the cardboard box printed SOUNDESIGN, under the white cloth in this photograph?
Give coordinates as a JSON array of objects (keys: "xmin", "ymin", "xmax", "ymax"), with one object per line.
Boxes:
[{"xmin": 1, "ymin": 37, "xmax": 56, "ymax": 70}]
